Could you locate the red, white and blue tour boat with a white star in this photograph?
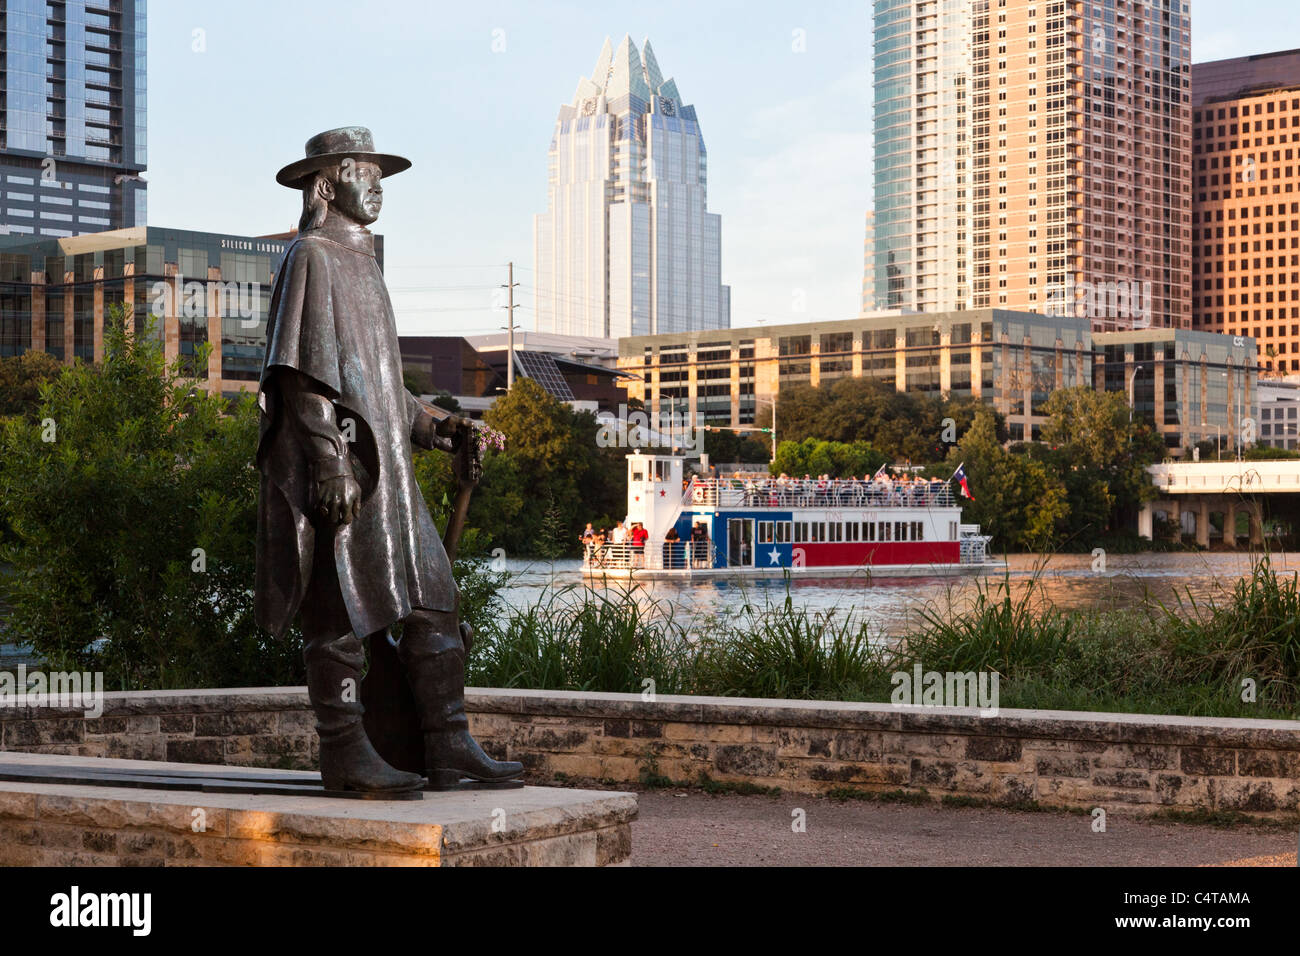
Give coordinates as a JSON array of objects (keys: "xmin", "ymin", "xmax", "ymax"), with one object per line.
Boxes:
[{"xmin": 582, "ymin": 453, "xmax": 1005, "ymax": 578}]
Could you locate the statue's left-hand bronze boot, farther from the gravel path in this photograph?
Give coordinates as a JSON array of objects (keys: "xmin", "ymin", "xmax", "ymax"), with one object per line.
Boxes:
[{"xmin": 303, "ymin": 633, "xmax": 425, "ymax": 793}]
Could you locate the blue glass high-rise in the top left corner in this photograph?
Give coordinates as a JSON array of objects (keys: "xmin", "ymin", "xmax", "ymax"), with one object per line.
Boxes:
[{"xmin": 0, "ymin": 0, "xmax": 147, "ymax": 237}]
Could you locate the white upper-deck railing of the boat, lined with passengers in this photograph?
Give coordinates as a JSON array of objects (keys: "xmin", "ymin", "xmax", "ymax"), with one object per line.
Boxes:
[{"xmin": 681, "ymin": 479, "xmax": 956, "ymax": 509}]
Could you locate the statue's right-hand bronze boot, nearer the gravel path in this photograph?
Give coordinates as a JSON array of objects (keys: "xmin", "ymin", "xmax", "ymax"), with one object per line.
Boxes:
[{"xmin": 398, "ymin": 610, "xmax": 524, "ymax": 790}]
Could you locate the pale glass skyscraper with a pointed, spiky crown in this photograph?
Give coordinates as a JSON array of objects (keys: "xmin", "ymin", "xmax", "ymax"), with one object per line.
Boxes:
[{"xmin": 533, "ymin": 36, "xmax": 731, "ymax": 338}]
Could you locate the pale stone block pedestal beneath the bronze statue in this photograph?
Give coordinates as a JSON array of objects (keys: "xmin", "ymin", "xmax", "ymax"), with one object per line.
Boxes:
[{"xmin": 0, "ymin": 753, "xmax": 637, "ymax": 866}]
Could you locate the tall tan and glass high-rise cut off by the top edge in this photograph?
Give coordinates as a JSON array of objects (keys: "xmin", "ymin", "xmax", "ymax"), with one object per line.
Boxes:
[{"xmin": 872, "ymin": 0, "xmax": 1191, "ymax": 330}]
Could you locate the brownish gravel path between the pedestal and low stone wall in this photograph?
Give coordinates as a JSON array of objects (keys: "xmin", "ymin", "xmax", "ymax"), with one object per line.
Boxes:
[{"xmin": 632, "ymin": 790, "xmax": 1296, "ymax": 866}]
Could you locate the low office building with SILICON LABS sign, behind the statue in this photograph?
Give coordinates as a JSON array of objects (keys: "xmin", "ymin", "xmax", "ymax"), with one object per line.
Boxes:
[{"xmin": 0, "ymin": 226, "xmax": 312, "ymax": 394}]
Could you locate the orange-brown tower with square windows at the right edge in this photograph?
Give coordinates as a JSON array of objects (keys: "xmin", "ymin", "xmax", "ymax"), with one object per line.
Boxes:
[{"xmin": 1192, "ymin": 49, "xmax": 1300, "ymax": 373}]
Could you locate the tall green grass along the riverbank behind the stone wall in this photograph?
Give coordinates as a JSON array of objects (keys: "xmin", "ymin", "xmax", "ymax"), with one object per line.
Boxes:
[{"xmin": 468, "ymin": 559, "xmax": 1300, "ymax": 717}]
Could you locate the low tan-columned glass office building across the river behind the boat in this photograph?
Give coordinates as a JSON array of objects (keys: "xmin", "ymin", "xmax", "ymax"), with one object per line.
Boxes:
[{"xmin": 619, "ymin": 310, "xmax": 1257, "ymax": 455}]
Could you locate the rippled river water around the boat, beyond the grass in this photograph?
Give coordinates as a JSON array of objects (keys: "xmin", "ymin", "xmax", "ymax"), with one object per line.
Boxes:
[{"xmin": 491, "ymin": 551, "xmax": 1300, "ymax": 636}]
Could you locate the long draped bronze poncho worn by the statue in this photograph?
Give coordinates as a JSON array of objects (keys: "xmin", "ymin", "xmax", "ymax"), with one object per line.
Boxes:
[{"xmin": 255, "ymin": 216, "xmax": 455, "ymax": 636}]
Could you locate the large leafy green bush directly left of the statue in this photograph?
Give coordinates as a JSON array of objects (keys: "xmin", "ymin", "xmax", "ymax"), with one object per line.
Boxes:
[{"xmin": 0, "ymin": 308, "xmax": 302, "ymax": 688}]
